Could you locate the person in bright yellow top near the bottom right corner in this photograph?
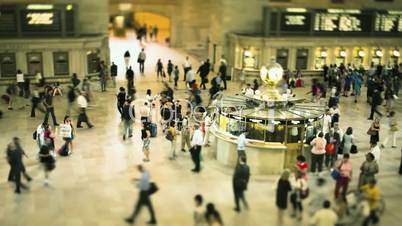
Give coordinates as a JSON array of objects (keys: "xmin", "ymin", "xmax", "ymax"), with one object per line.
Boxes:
[{"xmin": 360, "ymin": 179, "xmax": 381, "ymax": 226}]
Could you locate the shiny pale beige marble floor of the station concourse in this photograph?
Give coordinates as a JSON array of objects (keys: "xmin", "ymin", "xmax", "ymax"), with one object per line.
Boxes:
[{"xmin": 0, "ymin": 34, "xmax": 402, "ymax": 226}]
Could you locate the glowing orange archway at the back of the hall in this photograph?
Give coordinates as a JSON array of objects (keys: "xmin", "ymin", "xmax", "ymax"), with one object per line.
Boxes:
[{"xmin": 133, "ymin": 12, "xmax": 171, "ymax": 43}]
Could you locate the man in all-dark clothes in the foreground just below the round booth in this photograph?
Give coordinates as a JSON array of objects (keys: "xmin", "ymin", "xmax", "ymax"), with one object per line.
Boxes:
[{"xmin": 233, "ymin": 156, "xmax": 250, "ymax": 212}]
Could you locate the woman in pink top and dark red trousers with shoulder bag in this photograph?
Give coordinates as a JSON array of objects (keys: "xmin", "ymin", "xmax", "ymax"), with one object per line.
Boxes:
[{"xmin": 334, "ymin": 153, "xmax": 353, "ymax": 200}]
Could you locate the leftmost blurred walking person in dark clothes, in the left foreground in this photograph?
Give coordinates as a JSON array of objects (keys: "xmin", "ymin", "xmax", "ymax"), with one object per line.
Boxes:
[{"xmin": 7, "ymin": 137, "xmax": 32, "ymax": 194}]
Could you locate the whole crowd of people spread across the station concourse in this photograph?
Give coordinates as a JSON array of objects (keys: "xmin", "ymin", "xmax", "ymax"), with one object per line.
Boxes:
[{"xmin": 1, "ymin": 36, "xmax": 402, "ymax": 226}]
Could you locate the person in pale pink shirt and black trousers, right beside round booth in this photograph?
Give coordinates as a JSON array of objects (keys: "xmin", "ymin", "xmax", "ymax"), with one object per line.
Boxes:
[{"xmin": 310, "ymin": 132, "xmax": 327, "ymax": 173}]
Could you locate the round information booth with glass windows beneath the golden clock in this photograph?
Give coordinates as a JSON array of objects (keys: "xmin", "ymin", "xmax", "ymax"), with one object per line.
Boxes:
[{"xmin": 210, "ymin": 95, "xmax": 324, "ymax": 175}]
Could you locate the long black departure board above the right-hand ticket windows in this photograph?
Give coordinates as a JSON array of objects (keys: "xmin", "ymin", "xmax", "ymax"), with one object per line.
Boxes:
[{"xmin": 264, "ymin": 7, "xmax": 402, "ymax": 36}]
